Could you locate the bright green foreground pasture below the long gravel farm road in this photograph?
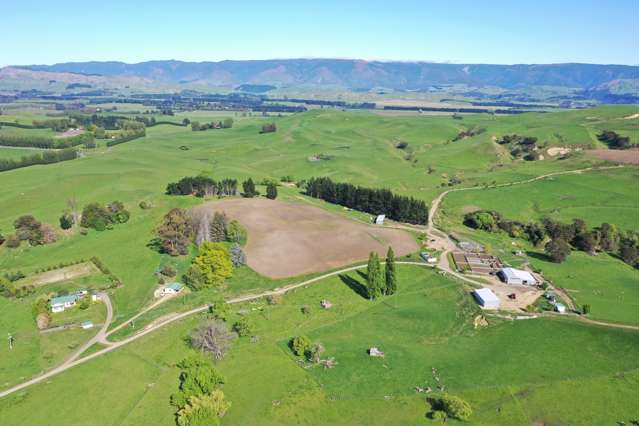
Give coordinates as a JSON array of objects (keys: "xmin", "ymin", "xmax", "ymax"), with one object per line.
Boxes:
[{"xmin": 0, "ymin": 266, "xmax": 639, "ymax": 425}]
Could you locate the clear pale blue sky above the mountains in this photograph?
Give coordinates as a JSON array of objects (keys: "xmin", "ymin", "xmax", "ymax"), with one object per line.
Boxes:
[{"xmin": 0, "ymin": 0, "xmax": 639, "ymax": 66}]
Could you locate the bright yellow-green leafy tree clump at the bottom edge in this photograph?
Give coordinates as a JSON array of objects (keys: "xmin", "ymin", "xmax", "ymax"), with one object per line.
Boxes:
[{"xmin": 171, "ymin": 356, "xmax": 231, "ymax": 426}]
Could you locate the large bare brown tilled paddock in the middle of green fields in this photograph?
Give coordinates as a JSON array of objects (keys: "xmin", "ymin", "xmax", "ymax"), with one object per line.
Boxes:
[{"xmin": 199, "ymin": 198, "xmax": 419, "ymax": 278}]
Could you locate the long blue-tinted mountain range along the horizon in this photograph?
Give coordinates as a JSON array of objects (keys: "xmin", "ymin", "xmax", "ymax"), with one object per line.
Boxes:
[{"xmin": 5, "ymin": 59, "xmax": 639, "ymax": 92}]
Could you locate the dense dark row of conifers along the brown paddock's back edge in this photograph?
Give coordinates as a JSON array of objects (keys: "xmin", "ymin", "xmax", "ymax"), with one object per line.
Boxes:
[{"xmin": 306, "ymin": 177, "xmax": 428, "ymax": 225}]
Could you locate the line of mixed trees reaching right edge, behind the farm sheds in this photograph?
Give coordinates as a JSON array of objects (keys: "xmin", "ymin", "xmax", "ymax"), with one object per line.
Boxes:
[{"xmin": 464, "ymin": 210, "xmax": 639, "ymax": 267}]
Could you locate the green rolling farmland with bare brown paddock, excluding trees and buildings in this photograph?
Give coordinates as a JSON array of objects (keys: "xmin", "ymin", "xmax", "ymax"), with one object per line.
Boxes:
[{"xmin": 0, "ymin": 104, "xmax": 639, "ymax": 425}]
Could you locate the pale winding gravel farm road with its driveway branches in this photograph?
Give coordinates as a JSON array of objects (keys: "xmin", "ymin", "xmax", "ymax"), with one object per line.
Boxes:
[{"xmin": 0, "ymin": 166, "xmax": 639, "ymax": 398}]
